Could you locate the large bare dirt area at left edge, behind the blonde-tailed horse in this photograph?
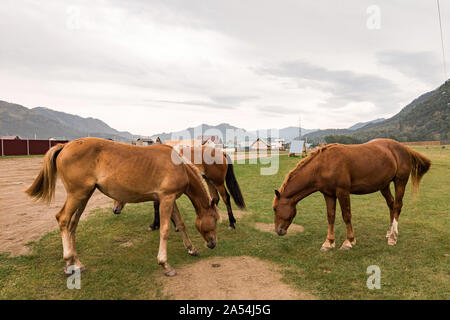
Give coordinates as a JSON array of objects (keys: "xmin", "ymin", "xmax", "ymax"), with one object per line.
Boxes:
[{"xmin": 0, "ymin": 157, "xmax": 112, "ymax": 256}]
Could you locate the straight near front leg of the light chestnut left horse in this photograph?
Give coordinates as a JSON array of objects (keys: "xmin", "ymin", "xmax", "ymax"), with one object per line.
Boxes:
[{"xmin": 158, "ymin": 196, "xmax": 177, "ymax": 277}]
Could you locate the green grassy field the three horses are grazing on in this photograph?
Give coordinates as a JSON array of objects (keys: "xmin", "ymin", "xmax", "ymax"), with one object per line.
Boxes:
[{"xmin": 0, "ymin": 147, "xmax": 450, "ymax": 299}]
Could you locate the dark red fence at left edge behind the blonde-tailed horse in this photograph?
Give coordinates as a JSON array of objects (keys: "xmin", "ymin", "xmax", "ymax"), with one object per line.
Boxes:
[{"xmin": 0, "ymin": 139, "xmax": 69, "ymax": 157}]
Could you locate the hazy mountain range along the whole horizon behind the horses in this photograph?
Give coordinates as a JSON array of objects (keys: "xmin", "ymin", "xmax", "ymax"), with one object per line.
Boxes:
[{"xmin": 0, "ymin": 80, "xmax": 450, "ymax": 143}]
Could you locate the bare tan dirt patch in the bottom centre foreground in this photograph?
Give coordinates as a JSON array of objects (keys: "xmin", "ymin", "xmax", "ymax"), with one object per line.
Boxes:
[{"xmin": 160, "ymin": 256, "xmax": 316, "ymax": 300}]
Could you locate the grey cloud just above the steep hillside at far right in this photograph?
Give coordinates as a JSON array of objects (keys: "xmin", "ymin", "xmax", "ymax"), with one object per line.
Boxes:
[{"xmin": 377, "ymin": 51, "xmax": 443, "ymax": 86}]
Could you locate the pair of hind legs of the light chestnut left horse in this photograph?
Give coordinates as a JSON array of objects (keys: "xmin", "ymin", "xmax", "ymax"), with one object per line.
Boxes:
[{"xmin": 56, "ymin": 190, "xmax": 93, "ymax": 272}]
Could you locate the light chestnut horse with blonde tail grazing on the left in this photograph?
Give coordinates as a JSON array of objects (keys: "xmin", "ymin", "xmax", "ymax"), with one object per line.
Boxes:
[{"xmin": 26, "ymin": 138, "xmax": 218, "ymax": 276}]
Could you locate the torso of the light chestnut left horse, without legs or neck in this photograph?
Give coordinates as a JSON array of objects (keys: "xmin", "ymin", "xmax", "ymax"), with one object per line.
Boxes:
[{"xmin": 57, "ymin": 138, "xmax": 188, "ymax": 202}]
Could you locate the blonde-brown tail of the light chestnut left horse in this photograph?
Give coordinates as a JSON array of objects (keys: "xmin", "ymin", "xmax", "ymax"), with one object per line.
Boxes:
[{"xmin": 25, "ymin": 144, "xmax": 64, "ymax": 203}]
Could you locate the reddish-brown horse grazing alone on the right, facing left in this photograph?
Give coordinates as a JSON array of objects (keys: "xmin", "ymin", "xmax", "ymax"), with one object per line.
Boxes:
[{"xmin": 273, "ymin": 139, "xmax": 431, "ymax": 251}]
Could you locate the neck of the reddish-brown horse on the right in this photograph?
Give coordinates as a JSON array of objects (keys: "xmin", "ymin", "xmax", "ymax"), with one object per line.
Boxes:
[{"xmin": 281, "ymin": 161, "xmax": 317, "ymax": 203}]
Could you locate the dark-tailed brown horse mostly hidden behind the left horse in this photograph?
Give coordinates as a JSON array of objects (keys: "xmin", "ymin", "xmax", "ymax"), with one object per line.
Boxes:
[{"xmin": 113, "ymin": 146, "xmax": 245, "ymax": 231}]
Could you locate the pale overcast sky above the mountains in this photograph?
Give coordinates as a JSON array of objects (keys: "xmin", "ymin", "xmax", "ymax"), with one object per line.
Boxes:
[{"xmin": 0, "ymin": 0, "xmax": 450, "ymax": 135}]
